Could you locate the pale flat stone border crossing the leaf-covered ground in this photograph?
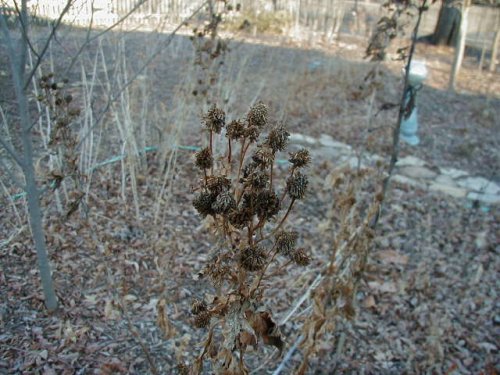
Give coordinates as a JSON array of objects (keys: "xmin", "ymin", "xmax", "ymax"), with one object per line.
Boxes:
[{"xmin": 290, "ymin": 133, "xmax": 500, "ymax": 205}]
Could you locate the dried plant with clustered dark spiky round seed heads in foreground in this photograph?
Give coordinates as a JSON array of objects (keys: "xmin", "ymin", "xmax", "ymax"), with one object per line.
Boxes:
[{"xmin": 184, "ymin": 103, "xmax": 310, "ymax": 374}]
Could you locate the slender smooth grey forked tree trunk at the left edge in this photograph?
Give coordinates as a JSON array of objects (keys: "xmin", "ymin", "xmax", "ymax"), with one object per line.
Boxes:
[{"xmin": 0, "ymin": 0, "xmax": 57, "ymax": 311}]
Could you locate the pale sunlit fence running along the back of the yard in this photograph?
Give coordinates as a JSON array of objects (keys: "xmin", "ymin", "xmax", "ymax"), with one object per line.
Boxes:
[{"xmin": 4, "ymin": 0, "xmax": 500, "ymax": 49}]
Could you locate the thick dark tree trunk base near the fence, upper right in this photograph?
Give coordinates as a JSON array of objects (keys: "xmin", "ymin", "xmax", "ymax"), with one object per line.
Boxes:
[{"xmin": 431, "ymin": 0, "xmax": 462, "ymax": 46}]
